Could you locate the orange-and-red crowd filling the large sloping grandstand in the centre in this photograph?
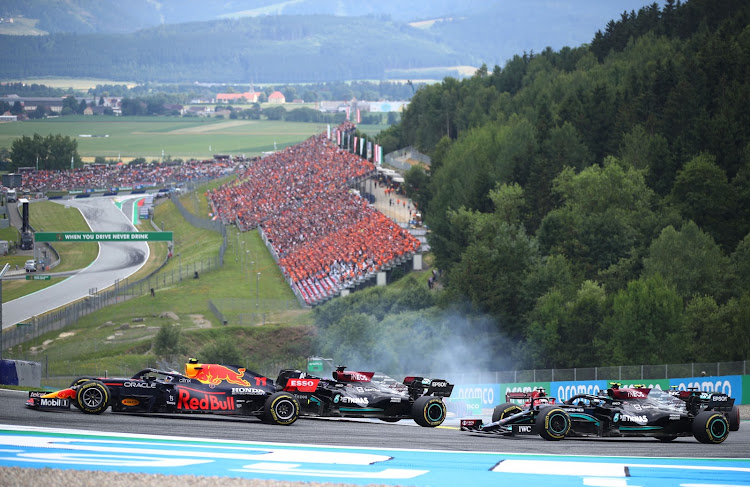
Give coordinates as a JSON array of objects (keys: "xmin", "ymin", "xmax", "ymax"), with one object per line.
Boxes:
[{"xmin": 209, "ymin": 126, "xmax": 419, "ymax": 304}]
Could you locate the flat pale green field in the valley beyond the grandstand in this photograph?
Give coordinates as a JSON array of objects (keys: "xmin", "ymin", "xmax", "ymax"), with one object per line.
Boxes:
[{"xmin": 0, "ymin": 116, "xmax": 394, "ymax": 160}]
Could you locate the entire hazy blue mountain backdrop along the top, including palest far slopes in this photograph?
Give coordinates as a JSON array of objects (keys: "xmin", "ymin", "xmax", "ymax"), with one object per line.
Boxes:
[{"xmin": 0, "ymin": 0, "xmax": 664, "ymax": 82}]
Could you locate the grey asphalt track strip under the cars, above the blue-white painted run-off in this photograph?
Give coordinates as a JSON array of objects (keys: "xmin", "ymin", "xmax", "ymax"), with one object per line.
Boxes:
[{"xmin": 0, "ymin": 390, "xmax": 750, "ymax": 459}]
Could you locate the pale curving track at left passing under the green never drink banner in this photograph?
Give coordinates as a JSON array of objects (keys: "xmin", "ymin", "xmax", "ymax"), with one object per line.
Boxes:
[{"xmin": 2, "ymin": 195, "xmax": 149, "ymax": 328}]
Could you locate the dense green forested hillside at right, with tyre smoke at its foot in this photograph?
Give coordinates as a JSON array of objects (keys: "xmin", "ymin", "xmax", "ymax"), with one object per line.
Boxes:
[{"xmin": 316, "ymin": 0, "xmax": 750, "ymax": 370}]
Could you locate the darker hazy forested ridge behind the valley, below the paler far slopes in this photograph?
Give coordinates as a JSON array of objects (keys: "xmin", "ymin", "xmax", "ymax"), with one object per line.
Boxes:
[{"xmin": 0, "ymin": 15, "xmax": 476, "ymax": 83}]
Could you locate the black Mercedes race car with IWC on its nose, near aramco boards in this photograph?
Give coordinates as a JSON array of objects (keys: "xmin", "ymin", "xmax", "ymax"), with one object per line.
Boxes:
[{"xmin": 461, "ymin": 384, "xmax": 740, "ymax": 443}]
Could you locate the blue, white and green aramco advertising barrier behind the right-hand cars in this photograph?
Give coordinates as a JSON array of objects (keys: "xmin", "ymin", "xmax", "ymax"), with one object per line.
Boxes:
[{"xmin": 451, "ymin": 375, "xmax": 750, "ymax": 410}]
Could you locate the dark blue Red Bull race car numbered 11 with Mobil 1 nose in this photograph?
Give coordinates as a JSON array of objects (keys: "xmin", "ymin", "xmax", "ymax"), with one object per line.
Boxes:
[{"xmin": 26, "ymin": 359, "xmax": 300, "ymax": 425}]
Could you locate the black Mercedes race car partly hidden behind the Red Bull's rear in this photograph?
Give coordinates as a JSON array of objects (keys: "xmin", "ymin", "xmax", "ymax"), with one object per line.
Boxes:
[{"xmin": 276, "ymin": 367, "xmax": 453, "ymax": 427}]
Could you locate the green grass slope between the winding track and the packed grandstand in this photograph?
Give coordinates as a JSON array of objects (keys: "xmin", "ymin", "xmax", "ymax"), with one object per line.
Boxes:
[{"xmin": 7, "ymin": 182, "xmax": 314, "ymax": 386}]
